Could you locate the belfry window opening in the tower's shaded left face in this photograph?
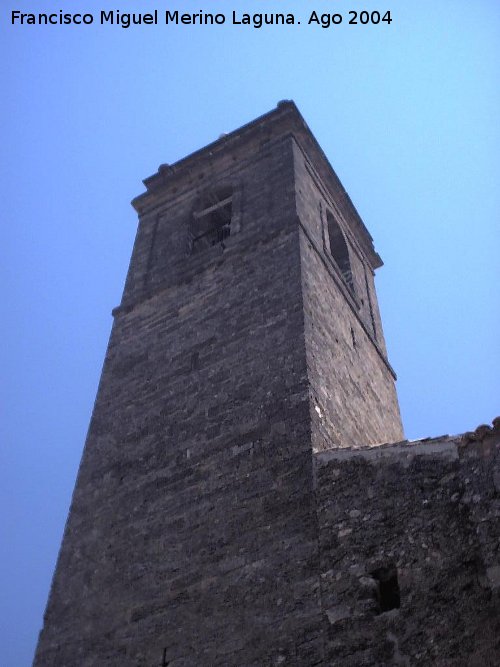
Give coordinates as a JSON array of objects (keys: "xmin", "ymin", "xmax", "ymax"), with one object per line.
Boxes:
[{"xmin": 191, "ymin": 188, "xmax": 233, "ymax": 254}]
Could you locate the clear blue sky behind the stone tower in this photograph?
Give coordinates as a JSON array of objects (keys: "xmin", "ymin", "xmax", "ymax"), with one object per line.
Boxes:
[{"xmin": 0, "ymin": 0, "xmax": 500, "ymax": 667}]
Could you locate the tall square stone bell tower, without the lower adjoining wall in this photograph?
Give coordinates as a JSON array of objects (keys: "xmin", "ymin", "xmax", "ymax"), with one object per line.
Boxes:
[{"xmin": 34, "ymin": 102, "xmax": 403, "ymax": 667}]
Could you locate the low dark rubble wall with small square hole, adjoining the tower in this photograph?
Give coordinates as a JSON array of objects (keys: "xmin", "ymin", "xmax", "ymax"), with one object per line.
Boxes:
[{"xmin": 316, "ymin": 422, "xmax": 500, "ymax": 667}]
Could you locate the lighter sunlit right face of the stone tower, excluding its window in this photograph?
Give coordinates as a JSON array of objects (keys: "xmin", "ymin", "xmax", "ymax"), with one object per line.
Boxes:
[{"xmin": 294, "ymin": 144, "xmax": 403, "ymax": 450}]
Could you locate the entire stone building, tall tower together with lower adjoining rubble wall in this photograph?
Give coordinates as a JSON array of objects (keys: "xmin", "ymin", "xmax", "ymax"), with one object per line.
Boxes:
[{"xmin": 34, "ymin": 102, "xmax": 500, "ymax": 667}]
